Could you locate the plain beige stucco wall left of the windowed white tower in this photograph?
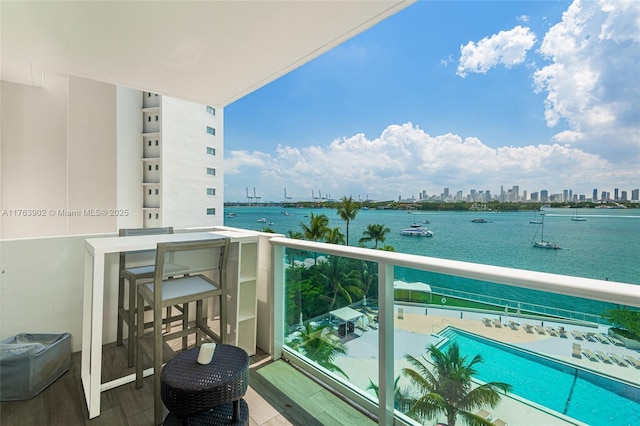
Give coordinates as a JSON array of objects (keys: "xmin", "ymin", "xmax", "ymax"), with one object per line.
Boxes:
[{"xmin": 0, "ymin": 73, "xmax": 117, "ymax": 238}]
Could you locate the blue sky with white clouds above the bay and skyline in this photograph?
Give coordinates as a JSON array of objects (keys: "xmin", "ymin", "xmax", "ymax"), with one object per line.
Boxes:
[{"xmin": 225, "ymin": 0, "xmax": 640, "ymax": 201}]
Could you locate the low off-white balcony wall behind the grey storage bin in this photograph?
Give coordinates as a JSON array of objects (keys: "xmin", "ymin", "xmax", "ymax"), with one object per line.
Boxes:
[{"xmin": 0, "ymin": 235, "xmax": 112, "ymax": 352}]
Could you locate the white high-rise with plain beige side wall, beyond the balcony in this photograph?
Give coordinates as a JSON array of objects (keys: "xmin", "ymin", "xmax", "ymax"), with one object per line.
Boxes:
[{"xmin": 0, "ymin": 81, "xmax": 224, "ymax": 238}]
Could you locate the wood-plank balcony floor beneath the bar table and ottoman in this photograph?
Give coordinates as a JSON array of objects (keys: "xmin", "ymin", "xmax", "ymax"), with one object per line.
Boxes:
[{"xmin": 0, "ymin": 345, "xmax": 375, "ymax": 426}]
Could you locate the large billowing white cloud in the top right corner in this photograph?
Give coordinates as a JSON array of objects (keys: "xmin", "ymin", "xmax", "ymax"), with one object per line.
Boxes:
[{"xmin": 533, "ymin": 0, "xmax": 640, "ymax": 163}]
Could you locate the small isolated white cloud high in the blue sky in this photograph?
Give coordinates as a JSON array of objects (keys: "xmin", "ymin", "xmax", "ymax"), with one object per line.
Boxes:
[{"xmin": 456, "ymin": 25, "xmax": 536, "ymax": 77}]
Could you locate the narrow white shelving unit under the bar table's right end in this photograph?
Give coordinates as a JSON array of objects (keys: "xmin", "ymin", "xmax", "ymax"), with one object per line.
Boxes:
[{"xmin": 222, "ymin": 236, "xmax": 258, "ymax": 355}]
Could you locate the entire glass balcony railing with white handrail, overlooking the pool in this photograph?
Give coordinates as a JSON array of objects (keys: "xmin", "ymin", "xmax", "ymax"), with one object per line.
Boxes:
[{"xmin": 272, "ymin": 239, "xmax": 640, "ymax": 425}]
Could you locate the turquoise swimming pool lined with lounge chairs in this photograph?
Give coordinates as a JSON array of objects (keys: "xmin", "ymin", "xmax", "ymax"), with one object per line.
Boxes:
[{"xmin": 439, "ymin": 327, "xmax": 640, "ymax": 425}]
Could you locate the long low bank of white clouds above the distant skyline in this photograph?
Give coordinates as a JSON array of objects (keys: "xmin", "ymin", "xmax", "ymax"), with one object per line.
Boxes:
[{"xmin": 225, "ymin": 123, "xmax": 637, "ymax": 201}]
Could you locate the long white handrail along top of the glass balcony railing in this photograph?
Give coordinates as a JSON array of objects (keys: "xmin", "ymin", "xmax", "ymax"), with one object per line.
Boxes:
[{"xmin": 269, "ymin": 236, "xmax": 640, "ymax": 308}]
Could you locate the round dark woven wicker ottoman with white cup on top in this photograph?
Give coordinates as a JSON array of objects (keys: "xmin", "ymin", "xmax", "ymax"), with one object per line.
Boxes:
[{"xmin": 160, "ymin": 345, "xmax": 249, "ymax": 425}]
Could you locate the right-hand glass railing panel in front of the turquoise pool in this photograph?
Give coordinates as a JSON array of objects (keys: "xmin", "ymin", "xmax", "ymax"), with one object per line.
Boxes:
[{"xmin": 394, "ymin": 267, "xmax": 640, "ymax": 424}]
